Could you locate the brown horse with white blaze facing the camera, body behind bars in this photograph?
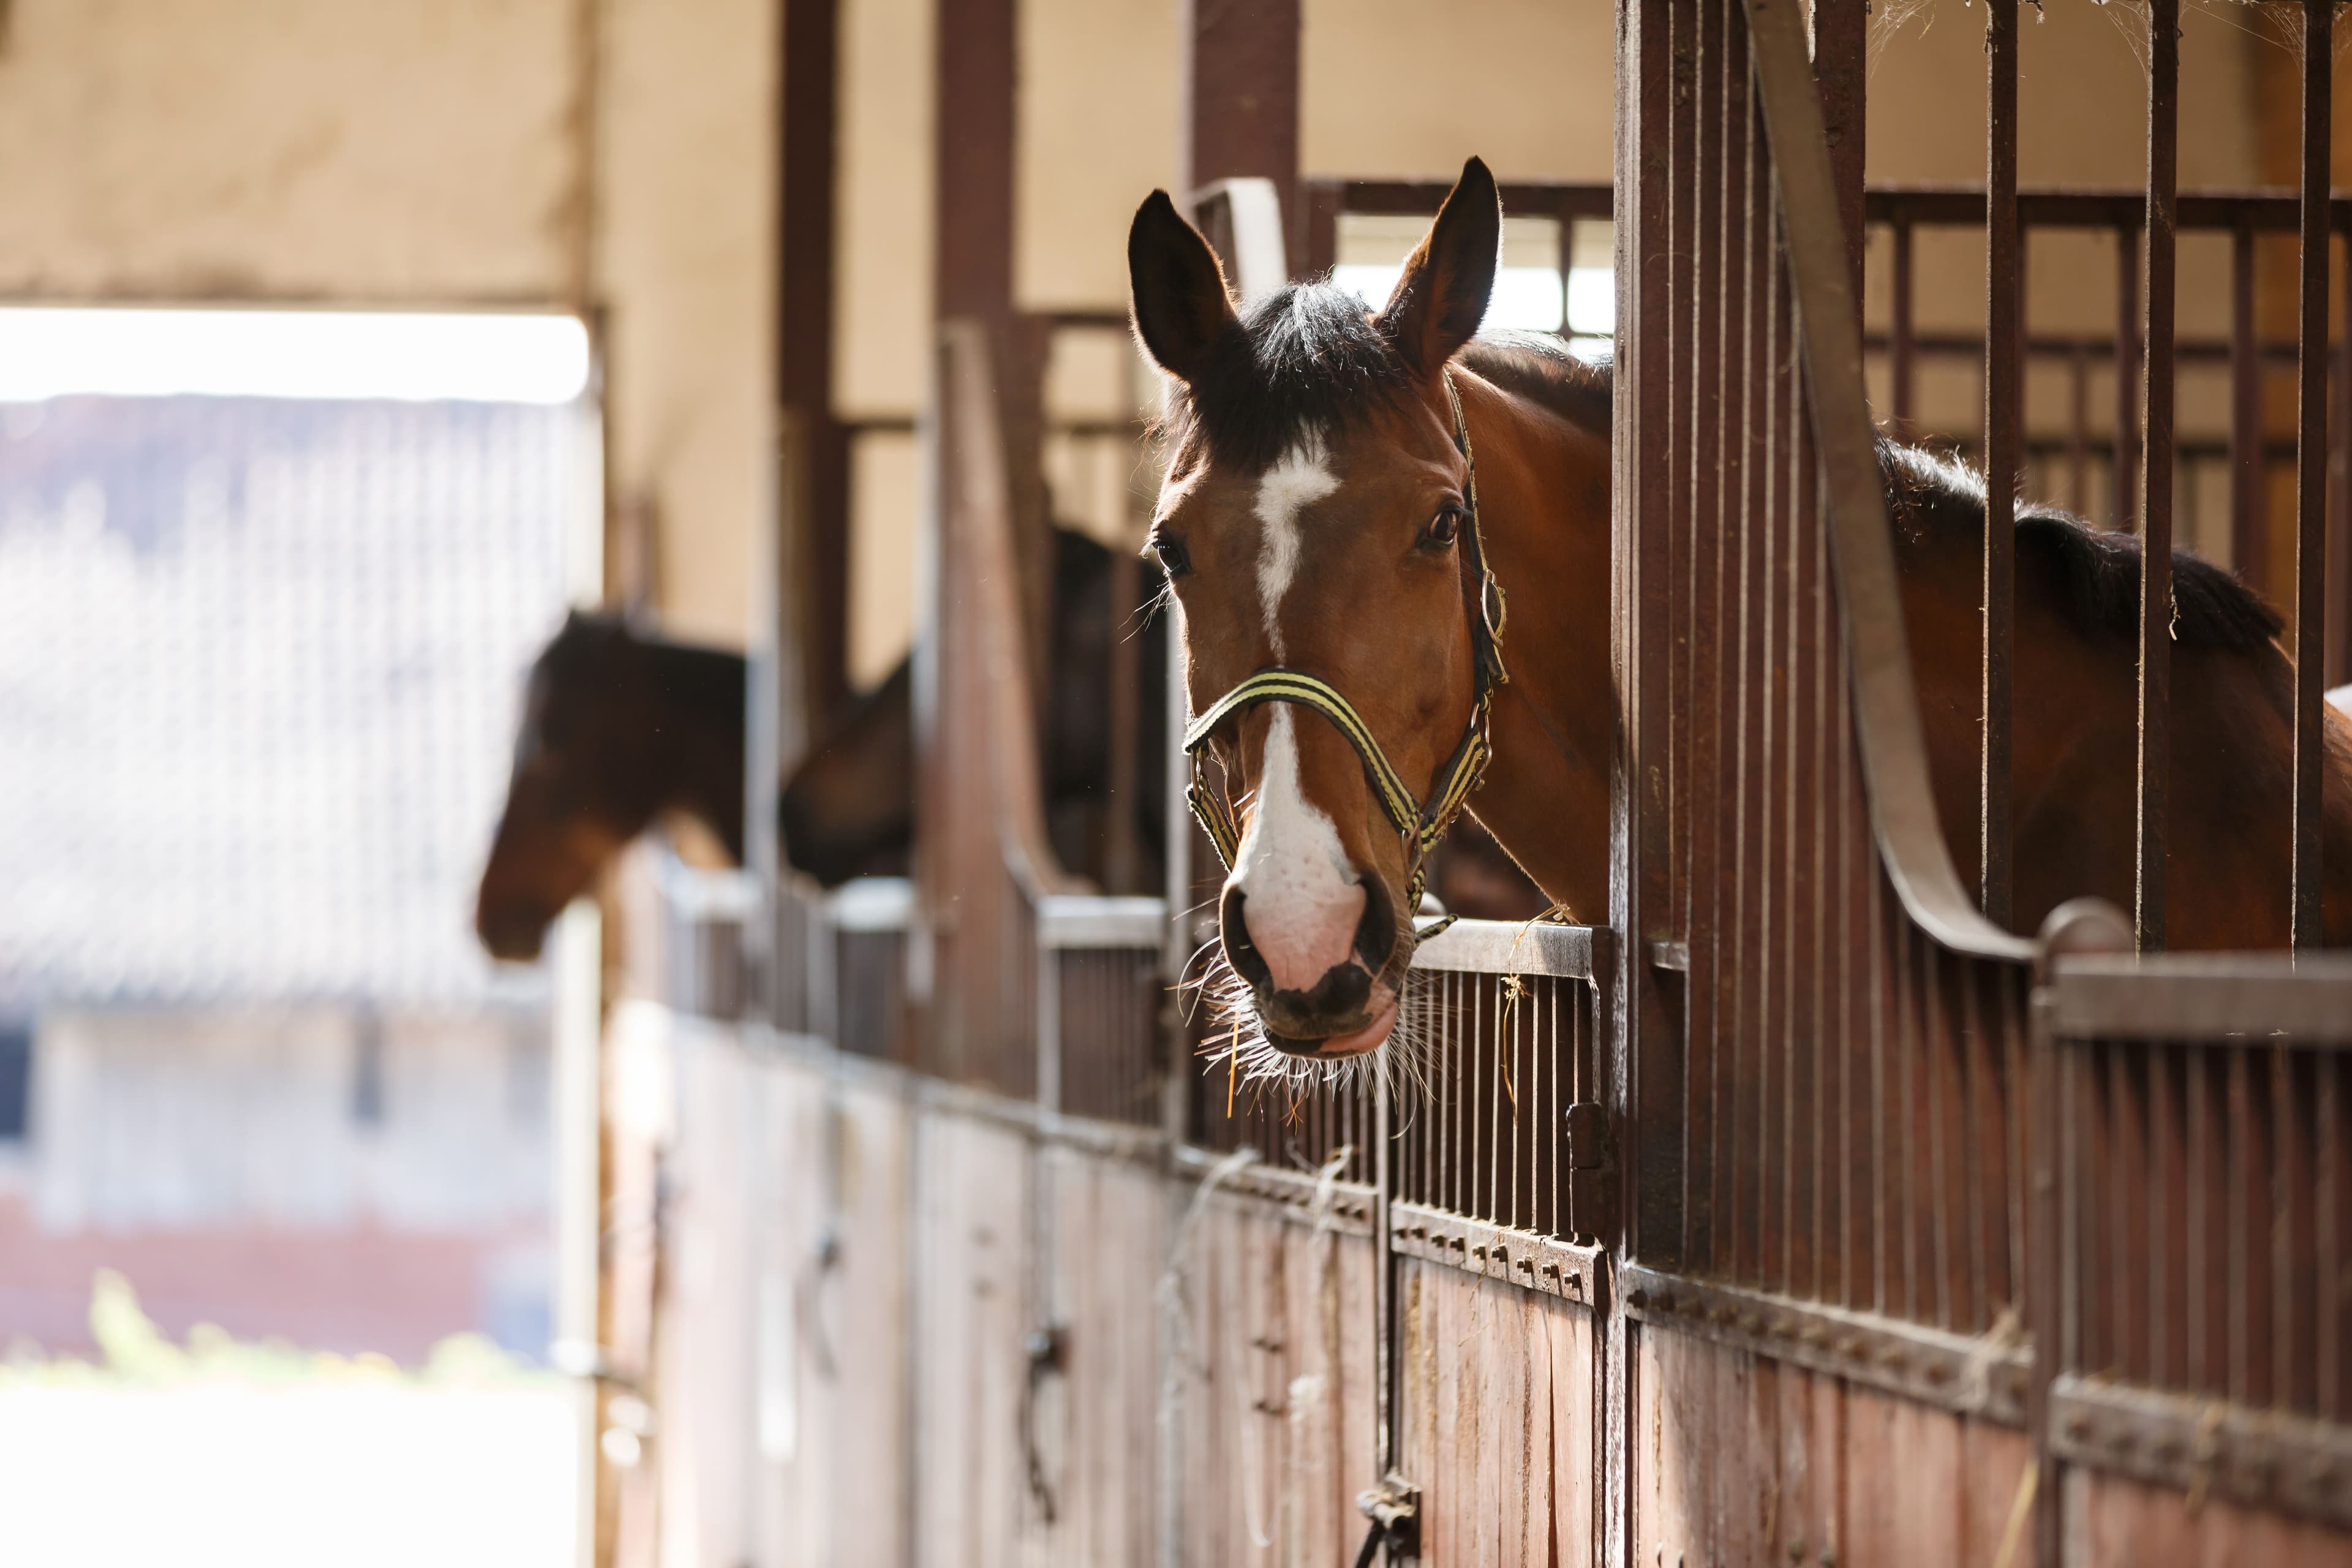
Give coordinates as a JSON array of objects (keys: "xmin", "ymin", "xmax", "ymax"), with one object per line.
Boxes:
[{"xmin": 1129, "ymin": 160, "xmax": 2352, "ymax": 1060}]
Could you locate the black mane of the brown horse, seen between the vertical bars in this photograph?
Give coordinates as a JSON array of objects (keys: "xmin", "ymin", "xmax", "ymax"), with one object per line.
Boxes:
[{"xmin": 1877, "ymin": 437, "xmax": 2286, "ymax": 654}]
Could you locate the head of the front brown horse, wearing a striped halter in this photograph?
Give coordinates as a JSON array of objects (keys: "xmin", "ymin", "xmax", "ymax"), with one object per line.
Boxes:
[{"xmin": 1126, "ymin": 160, "xmax": 1501, "ymax": 1060}]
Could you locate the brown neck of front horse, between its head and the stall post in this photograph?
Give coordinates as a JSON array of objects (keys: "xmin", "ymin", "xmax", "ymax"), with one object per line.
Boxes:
[{"xmin": 1458, "ymin": 374, "xmax": 1613, "ymax": 922}]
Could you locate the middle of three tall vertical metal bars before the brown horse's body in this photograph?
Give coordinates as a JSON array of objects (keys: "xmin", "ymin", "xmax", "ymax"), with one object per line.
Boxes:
[{"xmin": 2133, "ymin": 0, "xmax": 2180, "ymax": 952}]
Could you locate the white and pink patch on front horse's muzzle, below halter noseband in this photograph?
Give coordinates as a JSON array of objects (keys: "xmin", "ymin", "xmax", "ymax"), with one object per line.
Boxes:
[{"xmin": 1232, "ymin": 703, "xmax": 1364, "ymax": 990}]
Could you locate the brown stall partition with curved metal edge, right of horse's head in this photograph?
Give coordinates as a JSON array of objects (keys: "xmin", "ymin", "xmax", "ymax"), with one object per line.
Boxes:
[{"xmin": 1616, "ymin": 0, "xmax": 2032, "ymax": 1563}]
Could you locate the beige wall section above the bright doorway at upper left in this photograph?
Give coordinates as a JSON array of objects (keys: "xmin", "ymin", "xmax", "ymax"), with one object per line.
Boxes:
[{"xmin": 0, "ymin": 0, "xmax": 579, "ymax": 303}]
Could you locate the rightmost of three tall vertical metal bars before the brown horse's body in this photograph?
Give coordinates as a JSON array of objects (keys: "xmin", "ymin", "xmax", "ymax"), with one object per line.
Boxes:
[{"xmin": 2293, "ymin": 0, "xmax": 2335, "ymax": 950}]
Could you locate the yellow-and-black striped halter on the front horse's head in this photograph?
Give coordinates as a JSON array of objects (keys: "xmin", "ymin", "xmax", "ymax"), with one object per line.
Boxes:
[{"xmin": 1183, "ymin": 371, "xmax": 1510, "ymax": 940}]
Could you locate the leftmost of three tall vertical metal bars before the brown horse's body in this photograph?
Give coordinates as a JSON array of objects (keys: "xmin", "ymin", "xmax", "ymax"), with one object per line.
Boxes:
[{"xmin": 1976, "ymin": 0, "xmax": 2022, "ymax": 926}]
